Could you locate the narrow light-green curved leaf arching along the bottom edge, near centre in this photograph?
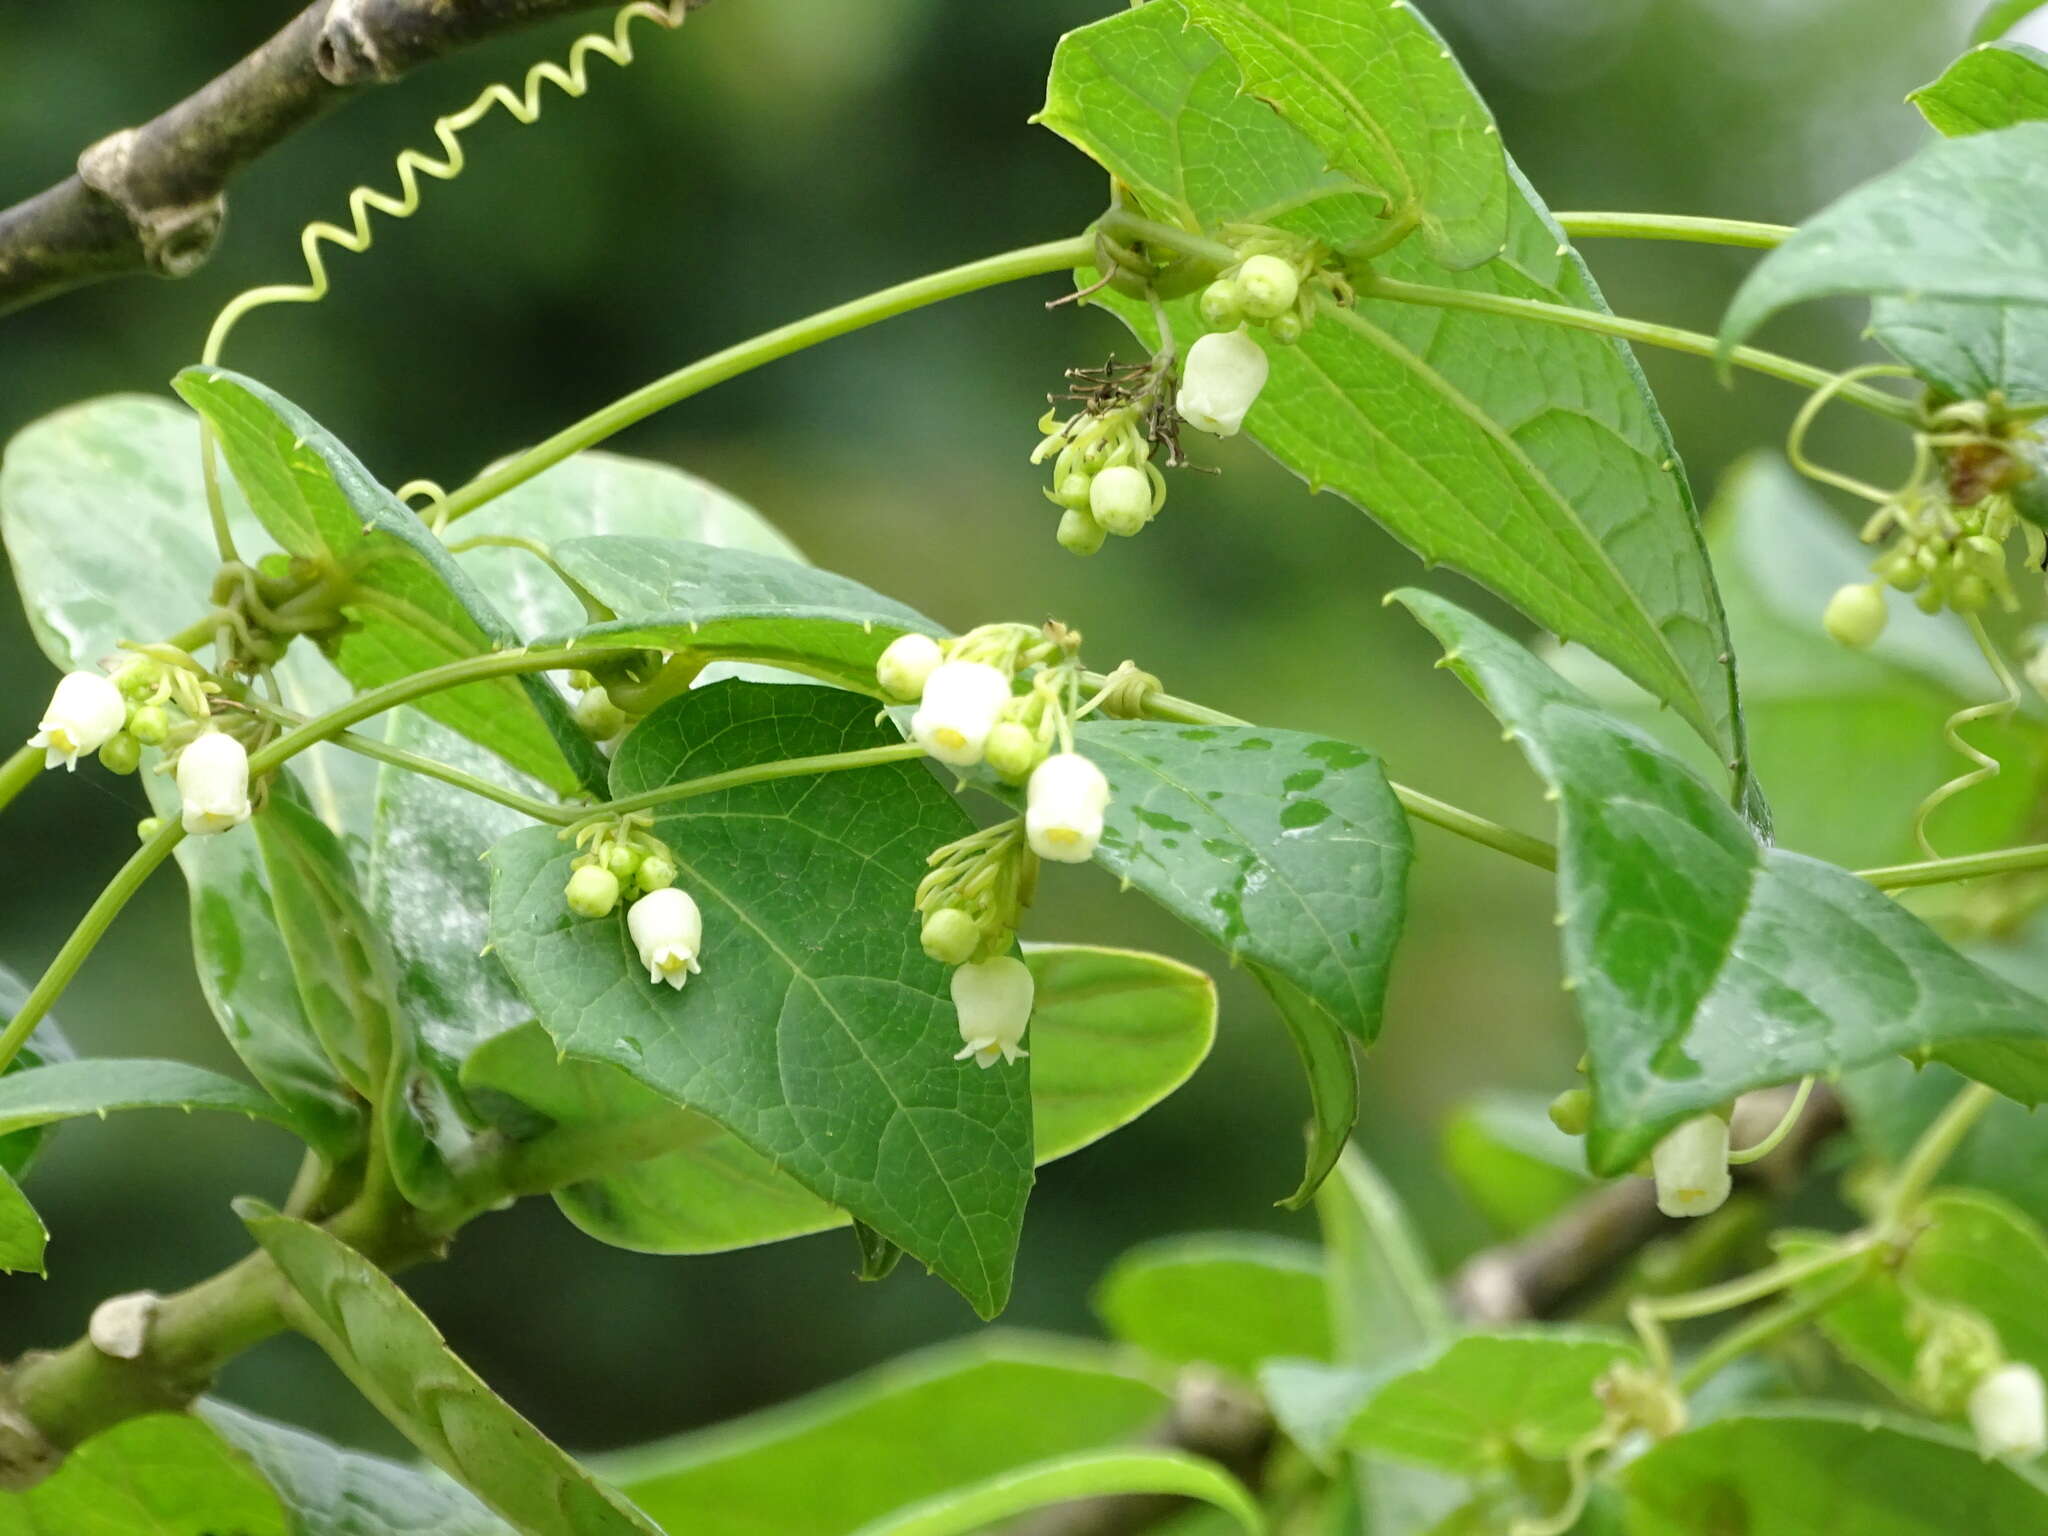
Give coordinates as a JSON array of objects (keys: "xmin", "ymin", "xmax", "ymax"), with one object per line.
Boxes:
[{"xmin": 856, "ymin": 1450, "xmax": 1266, "ymax": 1536}]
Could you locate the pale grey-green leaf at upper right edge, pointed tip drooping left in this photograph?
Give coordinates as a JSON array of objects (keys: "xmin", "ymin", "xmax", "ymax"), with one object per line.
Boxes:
[{"xmin": 1720, "ymin": 123, "xmax": 2048, "ymax": 362}]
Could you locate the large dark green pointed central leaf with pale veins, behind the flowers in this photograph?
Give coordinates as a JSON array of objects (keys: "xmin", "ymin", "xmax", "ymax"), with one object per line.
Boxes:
[{"xmin": 492, "ymin": 682, "xmax": 1032, "ymax": 1315}]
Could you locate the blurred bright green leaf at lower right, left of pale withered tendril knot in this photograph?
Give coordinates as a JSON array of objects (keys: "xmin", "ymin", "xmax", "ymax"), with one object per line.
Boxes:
[{"xmin": 1346, "ymin": 1331, "xmax": 1636, "ymax": 1475}]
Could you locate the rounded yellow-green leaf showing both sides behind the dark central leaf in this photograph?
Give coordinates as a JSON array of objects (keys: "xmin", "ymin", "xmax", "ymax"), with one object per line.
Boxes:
[{"xmin": 463, "ymin": 944, "xmax": 1217, "ymax": 1253}]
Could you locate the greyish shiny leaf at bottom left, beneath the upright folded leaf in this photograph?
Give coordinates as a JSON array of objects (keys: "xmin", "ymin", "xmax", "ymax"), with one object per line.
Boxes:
[{"xmin": 199, "ymin": 1401, "xmax": 514, "ymax": 1536}]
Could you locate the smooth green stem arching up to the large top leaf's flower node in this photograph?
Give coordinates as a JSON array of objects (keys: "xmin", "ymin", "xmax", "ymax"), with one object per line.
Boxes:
[{"xmin": 432, "ymin": 233, "xmax": 1096, "ymax": 526}]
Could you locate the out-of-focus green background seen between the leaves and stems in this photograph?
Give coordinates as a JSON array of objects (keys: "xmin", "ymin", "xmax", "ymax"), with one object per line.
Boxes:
[{"xmin": 0, "ymin": 0, "xmax": 2015, "ymax": 1448}]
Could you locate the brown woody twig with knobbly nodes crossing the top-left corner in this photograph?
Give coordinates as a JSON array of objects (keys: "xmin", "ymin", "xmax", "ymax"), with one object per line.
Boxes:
[{"xmin": 0, "ymin": 0, "xmax": 705, "ymax": 313}]
